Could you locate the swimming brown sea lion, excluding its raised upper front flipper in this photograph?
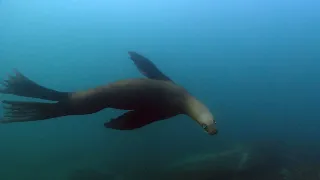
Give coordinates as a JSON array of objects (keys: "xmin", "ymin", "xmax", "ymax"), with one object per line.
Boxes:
[{"xmin": 0, "ymin": 53, "xmax": 218, "ymax": 135}]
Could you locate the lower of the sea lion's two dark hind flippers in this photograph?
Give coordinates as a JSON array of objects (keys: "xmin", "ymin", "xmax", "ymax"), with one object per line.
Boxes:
[{"xmin": 0, "ymin": 101, "xmax": 64, "ymax": 123}]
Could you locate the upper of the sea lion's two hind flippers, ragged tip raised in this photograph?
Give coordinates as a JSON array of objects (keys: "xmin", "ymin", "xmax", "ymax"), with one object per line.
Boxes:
[{"xmin": 0, "ymin": 70, "xmax": 69, "ymax": 101}]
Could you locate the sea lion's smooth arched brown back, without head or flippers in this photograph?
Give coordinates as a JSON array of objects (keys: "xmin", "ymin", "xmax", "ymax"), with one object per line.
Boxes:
[{"xmin": 70, "ymin": 78, "xmax": 187, "ymax": 110}]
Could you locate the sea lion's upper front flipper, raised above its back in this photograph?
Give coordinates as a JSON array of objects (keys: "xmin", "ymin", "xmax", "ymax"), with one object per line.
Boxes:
[{"xmin": 128, "ymin": 51, "xmax": 173, "ymax": 82}]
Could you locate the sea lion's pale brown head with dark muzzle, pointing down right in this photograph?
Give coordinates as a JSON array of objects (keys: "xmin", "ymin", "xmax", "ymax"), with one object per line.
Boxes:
[{"xmin": 185, "ymin": 96, "xmax": 218, "ymax": 135}]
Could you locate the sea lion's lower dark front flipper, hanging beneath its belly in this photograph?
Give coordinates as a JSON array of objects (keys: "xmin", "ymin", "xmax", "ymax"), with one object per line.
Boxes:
[{"xmin": 104, "ymin": 110, "xmax": 171, "ymax": 130}]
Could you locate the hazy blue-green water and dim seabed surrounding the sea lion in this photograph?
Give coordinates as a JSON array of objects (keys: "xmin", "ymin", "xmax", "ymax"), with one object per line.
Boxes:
[{"xmin": 0, "ymin": 0, "xmax": 320, "ymax": 180}]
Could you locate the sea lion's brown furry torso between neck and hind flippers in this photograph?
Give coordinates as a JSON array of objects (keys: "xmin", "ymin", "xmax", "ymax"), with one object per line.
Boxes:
[{"xmin": 56, "ymin": 78, "xmax": 190, "ymax": 116}]
